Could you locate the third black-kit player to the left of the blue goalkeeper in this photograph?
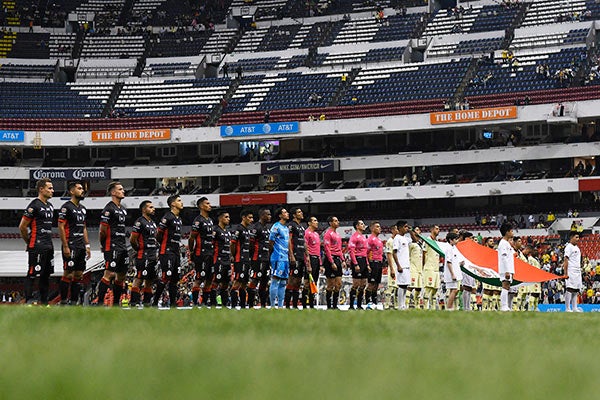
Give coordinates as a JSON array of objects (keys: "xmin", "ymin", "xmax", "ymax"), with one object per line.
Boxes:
[{"xmin": 213, "ymin": 210, "xmax": 233, "ymax": 308}]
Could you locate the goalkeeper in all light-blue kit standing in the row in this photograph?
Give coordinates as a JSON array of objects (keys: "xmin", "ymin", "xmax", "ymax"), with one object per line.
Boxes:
[{"xmin": 269, "ymin": 207, "xmax": 290, "ymax": 308}]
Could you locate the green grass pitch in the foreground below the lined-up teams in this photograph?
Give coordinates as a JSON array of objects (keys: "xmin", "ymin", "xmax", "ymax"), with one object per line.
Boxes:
[{"xmin": 0, "ymin": 306, "xmax": 598, "ymax": 400}]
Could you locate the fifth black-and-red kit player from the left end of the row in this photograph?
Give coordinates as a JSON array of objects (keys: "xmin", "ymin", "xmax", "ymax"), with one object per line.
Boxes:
[{"xmin": 153, "ymin": 194, "xmax": 183, "ymax": 308}]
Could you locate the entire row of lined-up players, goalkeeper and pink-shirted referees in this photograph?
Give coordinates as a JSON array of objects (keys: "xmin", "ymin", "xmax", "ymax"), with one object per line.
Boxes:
[{"xmin": 19, "ymin": 179, "xmax": 581, "ymax": 310}]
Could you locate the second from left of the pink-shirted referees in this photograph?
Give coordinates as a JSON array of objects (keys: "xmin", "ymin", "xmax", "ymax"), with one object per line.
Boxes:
[{"xmin": 323, "ymin": 216, "xmax": 346, "ymax": 310}]
